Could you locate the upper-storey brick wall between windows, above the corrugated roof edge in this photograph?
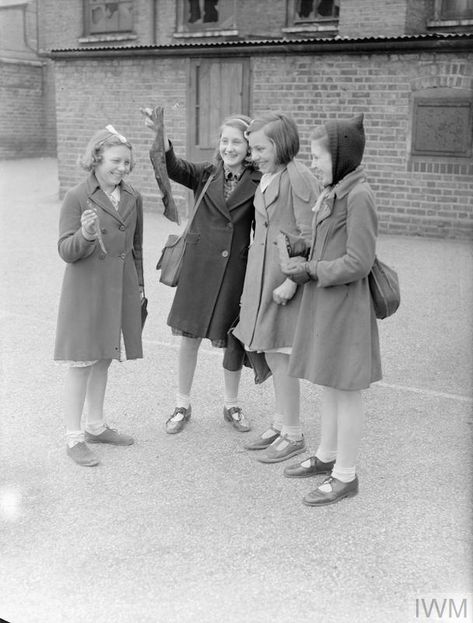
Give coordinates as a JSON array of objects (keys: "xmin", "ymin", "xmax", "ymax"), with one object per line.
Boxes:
[{"xmin": 38, "ymin": 0, "xmax": 433, "ymax": 50}]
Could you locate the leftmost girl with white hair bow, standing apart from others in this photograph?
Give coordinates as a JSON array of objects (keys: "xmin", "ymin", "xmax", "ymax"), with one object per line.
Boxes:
[{"xmin": 54, "ymin": 126, "xmax": 143, "ymax": 466}]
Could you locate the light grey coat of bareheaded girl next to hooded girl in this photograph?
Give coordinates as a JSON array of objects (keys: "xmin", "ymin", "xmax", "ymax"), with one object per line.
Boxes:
[{"xmin": 233, "ymin": 161, "xmax": 320, "ymax": 351}]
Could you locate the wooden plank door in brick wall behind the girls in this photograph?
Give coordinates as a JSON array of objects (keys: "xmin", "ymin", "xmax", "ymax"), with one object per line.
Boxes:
[{"xmin": 187, "ymin": 58, "xmax": 250, "ymax": 162}]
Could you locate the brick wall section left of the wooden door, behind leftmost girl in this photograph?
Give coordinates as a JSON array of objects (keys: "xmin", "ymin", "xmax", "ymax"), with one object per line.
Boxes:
[{"xmin": 55, "ymin": 54, "xmax": 188, "ymax": 209}]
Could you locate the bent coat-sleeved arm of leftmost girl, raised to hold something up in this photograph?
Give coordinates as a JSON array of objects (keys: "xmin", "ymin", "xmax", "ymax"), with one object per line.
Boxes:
[{"xmin": 58, "ymin": 186, "xmax": 96, "ymax": 263}]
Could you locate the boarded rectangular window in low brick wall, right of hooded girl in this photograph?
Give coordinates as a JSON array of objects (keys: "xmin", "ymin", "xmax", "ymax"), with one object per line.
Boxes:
[{"xmin": 412, "ymin": 98, "xmax": 473, "ymax": 158}]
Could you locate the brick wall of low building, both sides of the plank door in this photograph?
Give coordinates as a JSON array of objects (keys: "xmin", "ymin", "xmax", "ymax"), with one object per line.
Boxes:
[{"xmin": 51, "ymin": 47, "xmax": 473, "ymax": 238}]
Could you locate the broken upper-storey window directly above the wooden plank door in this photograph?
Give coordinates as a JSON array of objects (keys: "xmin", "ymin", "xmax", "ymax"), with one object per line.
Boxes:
[{"xmin": 179, "ymin": 0, "xmax": 236, "ymax": 31}]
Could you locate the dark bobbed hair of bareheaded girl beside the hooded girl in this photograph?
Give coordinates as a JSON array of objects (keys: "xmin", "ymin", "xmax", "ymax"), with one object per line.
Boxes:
[{"xmin": 246, "ymin": 112, "xmax": 299, "ymax": 164}]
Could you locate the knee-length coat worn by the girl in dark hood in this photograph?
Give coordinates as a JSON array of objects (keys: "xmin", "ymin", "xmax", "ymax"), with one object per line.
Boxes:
[{"xmin": 289, "ymin": 168, "xmax": 381, "ymax": 390}]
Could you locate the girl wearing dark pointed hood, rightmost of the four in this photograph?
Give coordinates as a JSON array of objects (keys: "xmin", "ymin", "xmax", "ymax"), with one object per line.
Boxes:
[{"xmin": 282, "ymin": 115, "xmax": 381, "ymax": 506}]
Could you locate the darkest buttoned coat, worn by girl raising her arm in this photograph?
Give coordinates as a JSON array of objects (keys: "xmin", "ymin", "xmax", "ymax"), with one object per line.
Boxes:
[{"xmin": 161, "ymin": 148, "xmax": 261, "ymax": 340}]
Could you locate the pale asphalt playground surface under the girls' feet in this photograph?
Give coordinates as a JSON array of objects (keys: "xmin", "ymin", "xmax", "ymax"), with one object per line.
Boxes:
[{"xmin": 0, "ymin": 159, "xmax": 473, "ymax": 623}]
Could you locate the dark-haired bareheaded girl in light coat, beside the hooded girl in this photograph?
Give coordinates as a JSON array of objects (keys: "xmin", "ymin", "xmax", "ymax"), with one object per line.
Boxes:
[{"xmin": 234, "ymin": 113, "xmax": 319, "ymax": 463}]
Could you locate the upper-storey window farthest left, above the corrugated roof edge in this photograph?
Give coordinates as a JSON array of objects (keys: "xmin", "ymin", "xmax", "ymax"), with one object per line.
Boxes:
[{"xmin": 85, "ymin": 0, "xmax": 133, "ymax": 35}]
